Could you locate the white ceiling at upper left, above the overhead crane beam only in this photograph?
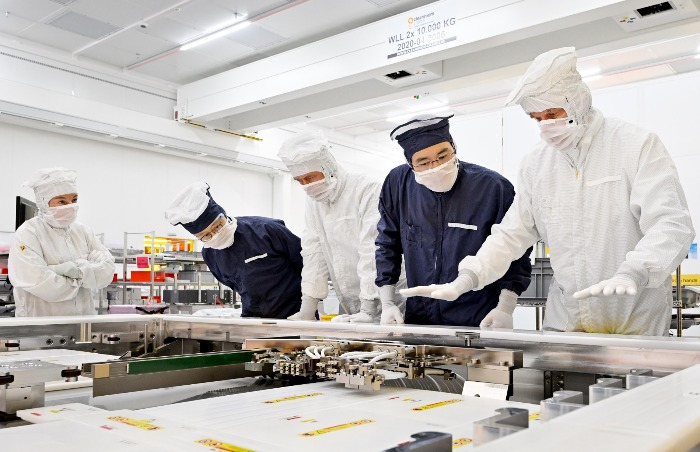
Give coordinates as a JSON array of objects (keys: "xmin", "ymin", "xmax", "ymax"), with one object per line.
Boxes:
[{"xmin": 0, "ymin": 0, "xmax": 434, "ymax": 85}]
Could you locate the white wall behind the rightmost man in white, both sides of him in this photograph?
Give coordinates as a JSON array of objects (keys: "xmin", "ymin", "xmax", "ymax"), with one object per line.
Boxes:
[{"xmin": 450, "ymin": 72, "xmax": 700, "ymax": 264}]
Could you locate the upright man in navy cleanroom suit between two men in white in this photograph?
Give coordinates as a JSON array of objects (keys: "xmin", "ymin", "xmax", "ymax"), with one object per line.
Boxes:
[{"xmin": 376, "ymin": 116, "xmax": 531, "ymax": 328}]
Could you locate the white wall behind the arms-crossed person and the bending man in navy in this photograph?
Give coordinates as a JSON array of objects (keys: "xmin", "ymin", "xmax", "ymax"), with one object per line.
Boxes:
[{"xmin": 0, "ymin": 123, "xmax": 273, "ymax": 247}]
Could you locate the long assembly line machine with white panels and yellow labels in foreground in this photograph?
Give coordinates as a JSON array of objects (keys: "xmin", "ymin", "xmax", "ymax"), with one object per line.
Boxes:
[{"xmin": 0, "ymin": 315, "xmax": 700, "ymax": 451}]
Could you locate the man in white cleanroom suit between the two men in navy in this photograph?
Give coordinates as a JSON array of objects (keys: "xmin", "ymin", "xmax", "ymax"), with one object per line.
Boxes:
[{"xmin": 279, "ymin": 131, "xmax": 402, "ymax": 323}]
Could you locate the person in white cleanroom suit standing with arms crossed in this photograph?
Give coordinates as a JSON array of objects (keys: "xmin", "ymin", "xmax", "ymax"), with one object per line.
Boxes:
[{"xmin": 8, "ymin": 168, "xmax": 115, "ymax": 317}]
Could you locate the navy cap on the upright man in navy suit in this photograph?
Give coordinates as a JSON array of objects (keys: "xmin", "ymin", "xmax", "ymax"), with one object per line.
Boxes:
[{"xmin": 390, "ymin": 115, "xmax": 454, "ymax": 162}]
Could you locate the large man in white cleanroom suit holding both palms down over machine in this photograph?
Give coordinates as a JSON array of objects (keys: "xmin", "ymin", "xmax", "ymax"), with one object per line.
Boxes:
[{"xmin": 400, "ymin": 47, "xmax": 695, "ymax": 336}]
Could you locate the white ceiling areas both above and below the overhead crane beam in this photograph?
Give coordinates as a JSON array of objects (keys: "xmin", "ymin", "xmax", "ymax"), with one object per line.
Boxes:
[{"xmin": 0, "ymin": 0, "xmax": 700, "ymax": 141}]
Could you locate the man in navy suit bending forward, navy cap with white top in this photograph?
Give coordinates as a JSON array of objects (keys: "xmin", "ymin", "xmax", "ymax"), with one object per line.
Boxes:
[{"xmin": 166, "ymin": 182, "xmax": 303, "ymax": 319}]
